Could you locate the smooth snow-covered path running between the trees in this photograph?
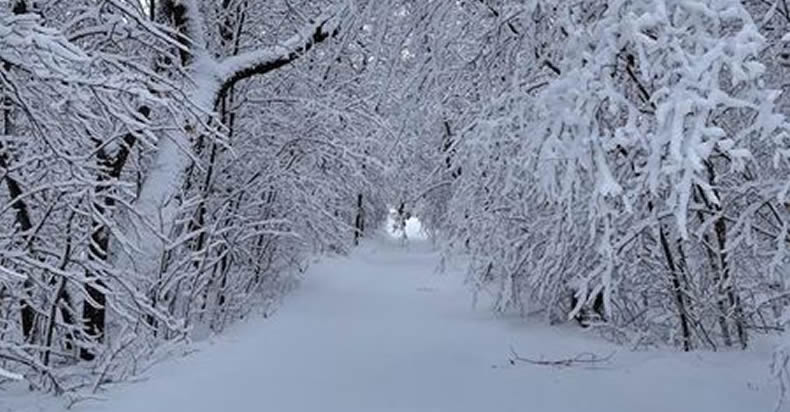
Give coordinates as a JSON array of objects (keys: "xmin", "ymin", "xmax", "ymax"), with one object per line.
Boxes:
[{"xmin": 0, "ymin": 237, "xmax": 777, "ymax": 412}]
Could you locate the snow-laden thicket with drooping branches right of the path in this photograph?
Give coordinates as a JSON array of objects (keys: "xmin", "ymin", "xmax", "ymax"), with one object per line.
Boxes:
[{"xmin": 420, "ymin": 0, "xmax": 788, "ymax": 350}]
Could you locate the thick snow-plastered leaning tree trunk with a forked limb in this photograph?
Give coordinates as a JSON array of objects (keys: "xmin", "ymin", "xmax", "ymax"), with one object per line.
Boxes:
[{"xmin": 110, "ymin": 0, "xmax": 340, "ymax": 342}]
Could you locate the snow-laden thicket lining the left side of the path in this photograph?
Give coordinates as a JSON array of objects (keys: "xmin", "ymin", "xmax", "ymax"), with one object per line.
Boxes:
[{"xmin": 0, "ymin": 0, "xmax": 383, "ymax": 391}]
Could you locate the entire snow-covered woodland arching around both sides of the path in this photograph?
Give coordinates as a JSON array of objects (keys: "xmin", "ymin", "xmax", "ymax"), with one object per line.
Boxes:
[{"xmin": 0, "ymin": 0, "xmax": 790, "ymax": 402}]
